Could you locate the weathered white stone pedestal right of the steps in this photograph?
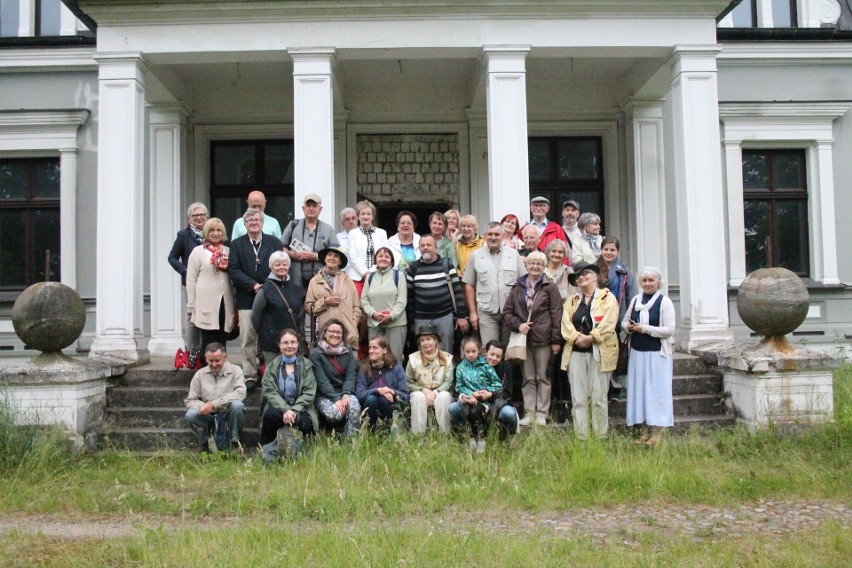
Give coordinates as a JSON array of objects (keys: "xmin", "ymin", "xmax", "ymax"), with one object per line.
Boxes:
[{"xmin": 718, "ymin": 340, "xmax": 840, "ymax": 431}]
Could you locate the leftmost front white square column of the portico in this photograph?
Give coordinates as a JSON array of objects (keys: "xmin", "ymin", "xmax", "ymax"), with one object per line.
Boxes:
[{"xmin": 90, "ymin": 53, "xmax": 150, "ymax": 362}]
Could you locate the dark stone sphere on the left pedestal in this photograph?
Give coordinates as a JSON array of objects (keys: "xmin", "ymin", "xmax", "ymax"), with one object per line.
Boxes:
[{"xmin": 12, "ymin": 282, "xmax": 86, "ymax": 352}]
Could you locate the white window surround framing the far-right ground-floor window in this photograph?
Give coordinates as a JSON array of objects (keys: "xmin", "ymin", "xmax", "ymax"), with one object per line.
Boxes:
[{"xmin": 719, "ymin": 102, "xmax": 850, "ymax": 286}]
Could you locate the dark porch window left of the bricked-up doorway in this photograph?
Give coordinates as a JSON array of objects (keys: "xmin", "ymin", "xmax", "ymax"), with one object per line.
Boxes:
[{"xmin": 210, "ymin": 140, "xmax": 295, "ymax": 237}]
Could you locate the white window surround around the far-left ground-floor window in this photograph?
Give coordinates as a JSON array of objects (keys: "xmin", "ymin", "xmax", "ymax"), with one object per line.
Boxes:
[{"xmin": 0, "ymin": 109, "xmax": 89, "ymax": 288}]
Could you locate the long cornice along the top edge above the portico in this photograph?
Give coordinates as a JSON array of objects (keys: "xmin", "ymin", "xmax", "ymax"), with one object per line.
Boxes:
[{"xmin": 78, "ymin": 0, "xmax": 729, "ymax": 26}]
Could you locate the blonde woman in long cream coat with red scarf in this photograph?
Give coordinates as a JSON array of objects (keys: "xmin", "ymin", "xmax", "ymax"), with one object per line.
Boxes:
[{"xmin": 186, "ymin": 217, "xmax": 234, "ymax": 362}]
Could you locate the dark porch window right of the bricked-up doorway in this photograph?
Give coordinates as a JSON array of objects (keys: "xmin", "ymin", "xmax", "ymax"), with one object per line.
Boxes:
[{"xmin": 521, "ymin": 136, "xmax": 604, "ymax": 227}]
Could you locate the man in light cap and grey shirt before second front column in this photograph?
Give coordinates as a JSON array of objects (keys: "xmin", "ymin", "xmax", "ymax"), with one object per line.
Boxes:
[{"xmin": 281, "ymin": 193, "xmax": 340, "ymax": 290}]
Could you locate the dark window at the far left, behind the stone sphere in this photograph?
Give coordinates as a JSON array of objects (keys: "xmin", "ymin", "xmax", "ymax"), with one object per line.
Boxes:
[{"xmin": 0, "ymin": 158, "xmax": 60, "ymax": 290}]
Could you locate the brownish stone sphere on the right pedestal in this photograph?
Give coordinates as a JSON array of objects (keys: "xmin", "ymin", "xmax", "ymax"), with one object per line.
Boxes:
[{"xmin": 737, "ymin": 268, "xmax": 809, "ymax": 344}]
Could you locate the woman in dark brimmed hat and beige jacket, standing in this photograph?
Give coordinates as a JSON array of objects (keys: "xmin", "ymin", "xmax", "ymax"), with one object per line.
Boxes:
[{"xmin": 305, "ymin": 248, "xmax": 363, "ymax": 350}]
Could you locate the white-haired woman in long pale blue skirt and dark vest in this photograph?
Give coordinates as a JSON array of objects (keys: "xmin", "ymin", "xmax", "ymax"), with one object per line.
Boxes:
[{"xmin": 621, "ymin": 266, "xmax": 675, "ymax": 446}]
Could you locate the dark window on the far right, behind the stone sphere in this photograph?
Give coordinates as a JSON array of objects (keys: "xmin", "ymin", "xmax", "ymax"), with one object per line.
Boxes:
[{"xmin": 743, "ymin": 150, "xmax": 809, "ymax": 276}]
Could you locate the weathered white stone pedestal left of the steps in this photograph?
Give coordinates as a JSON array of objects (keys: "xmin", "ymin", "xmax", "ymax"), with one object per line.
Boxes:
[{"xmin": 0, "ymin": 353, "xmax": 125, "ymax": 447}]
